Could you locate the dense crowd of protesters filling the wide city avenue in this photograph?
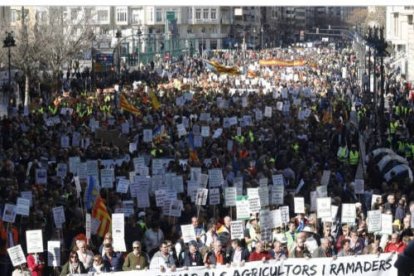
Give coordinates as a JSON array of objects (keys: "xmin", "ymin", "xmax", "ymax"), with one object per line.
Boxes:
[{"xmin": 0, "ymin": 41, "xmax": 414, "ymax": 275}]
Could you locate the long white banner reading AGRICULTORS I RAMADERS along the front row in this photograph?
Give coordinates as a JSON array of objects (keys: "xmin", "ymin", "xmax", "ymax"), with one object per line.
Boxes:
[{"xmin": 74, "ymin": 253, "xmax": 398, "ymax": 276}]
